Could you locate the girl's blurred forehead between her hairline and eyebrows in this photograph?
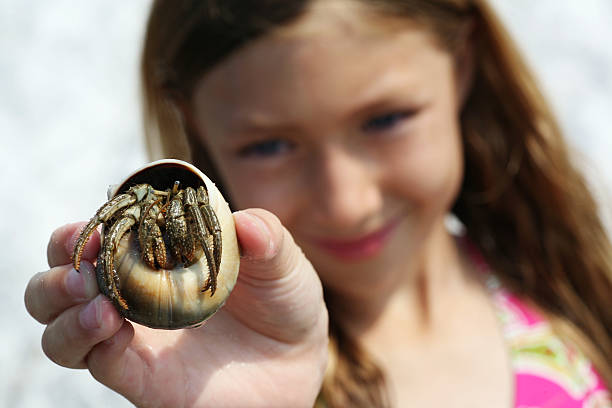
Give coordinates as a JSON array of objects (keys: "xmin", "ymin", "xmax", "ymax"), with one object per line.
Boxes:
[{"xmin": 194, "ymin": 0, "xmax": 442, "ymax": 127}]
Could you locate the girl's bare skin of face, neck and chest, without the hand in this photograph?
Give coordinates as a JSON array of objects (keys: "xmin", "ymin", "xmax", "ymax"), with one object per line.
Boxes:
[{"xmin": 187, "ymin": 2, "xmax": 512, "ymax": 407}]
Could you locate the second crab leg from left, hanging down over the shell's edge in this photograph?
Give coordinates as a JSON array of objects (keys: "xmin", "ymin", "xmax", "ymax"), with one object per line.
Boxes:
[{"xmin": 100, "ymin": 206, "xmax": 140, "ymax": 310}]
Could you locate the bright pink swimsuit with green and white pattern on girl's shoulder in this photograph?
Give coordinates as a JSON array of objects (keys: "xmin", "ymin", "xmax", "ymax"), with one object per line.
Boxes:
[{"xmin": 467, "ymin": 244, "xmax": 612, "ymax": 408}]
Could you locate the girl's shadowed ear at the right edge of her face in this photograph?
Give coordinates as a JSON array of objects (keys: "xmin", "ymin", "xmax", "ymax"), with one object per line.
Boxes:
[{"xmin": 454, "ymin": 21, "xmax": 476, "ymax": 109}]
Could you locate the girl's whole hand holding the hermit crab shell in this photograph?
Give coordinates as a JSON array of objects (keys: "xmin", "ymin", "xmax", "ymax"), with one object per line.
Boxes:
[{"xmin": 25, "ymin": 209, "xmax": 327, "ymax": 407}]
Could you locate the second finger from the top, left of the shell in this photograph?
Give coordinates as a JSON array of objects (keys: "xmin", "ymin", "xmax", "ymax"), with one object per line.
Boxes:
[{"xmin": 24, "ymin": 261, "xmax": 99, "ymax": 324}]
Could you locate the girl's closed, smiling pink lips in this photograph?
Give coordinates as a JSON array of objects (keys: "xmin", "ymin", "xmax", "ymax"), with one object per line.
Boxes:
[{"xmin": 314, "ymin": 218, "xmax": 400, "ymax": 261}]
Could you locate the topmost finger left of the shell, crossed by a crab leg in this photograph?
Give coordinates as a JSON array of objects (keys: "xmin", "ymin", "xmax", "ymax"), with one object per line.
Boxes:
[{"xmin": 47, "ymin": 222, "xmax": 100, "ymax": 268}]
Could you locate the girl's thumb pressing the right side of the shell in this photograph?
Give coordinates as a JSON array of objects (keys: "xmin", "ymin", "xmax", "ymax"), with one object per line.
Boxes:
[{"xmin": 226, "ymin": 209, "xmax": 327, "ymax": 343}]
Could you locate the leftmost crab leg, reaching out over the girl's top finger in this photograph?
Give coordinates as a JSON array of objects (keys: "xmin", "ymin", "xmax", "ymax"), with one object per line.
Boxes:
[{"xmin": 72, "ymin": 184, "xmax": 153, "ymax": 271}]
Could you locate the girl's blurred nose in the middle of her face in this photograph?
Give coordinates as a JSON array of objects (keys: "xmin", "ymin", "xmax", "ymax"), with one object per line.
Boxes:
[{"xmin": 311, "ymin": 146, "xmax": 383, "ymax": 231}]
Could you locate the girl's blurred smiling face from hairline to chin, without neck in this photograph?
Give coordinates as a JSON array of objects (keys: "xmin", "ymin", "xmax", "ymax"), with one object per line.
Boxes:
[{"xmin": 189, "ymin": 2, "xmax": 462, "ymax": 290}]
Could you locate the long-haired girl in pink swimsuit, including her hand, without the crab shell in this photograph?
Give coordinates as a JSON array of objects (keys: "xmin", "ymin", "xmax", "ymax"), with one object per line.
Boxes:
[{"xmin": 26, "ymin": 0, "xmax": 612, "ymax": 407}]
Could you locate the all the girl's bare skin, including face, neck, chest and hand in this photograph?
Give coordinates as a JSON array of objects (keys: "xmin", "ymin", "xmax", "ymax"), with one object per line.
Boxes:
[{"xmin": 25, "ymin": 1, "xmax": 511, "ymax": 407}]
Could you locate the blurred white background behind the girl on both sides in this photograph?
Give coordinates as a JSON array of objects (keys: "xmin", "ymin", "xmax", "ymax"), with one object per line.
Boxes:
[{"xmin": 0, "ymin": 0, "xmax": 612, "ymax": 408}]
